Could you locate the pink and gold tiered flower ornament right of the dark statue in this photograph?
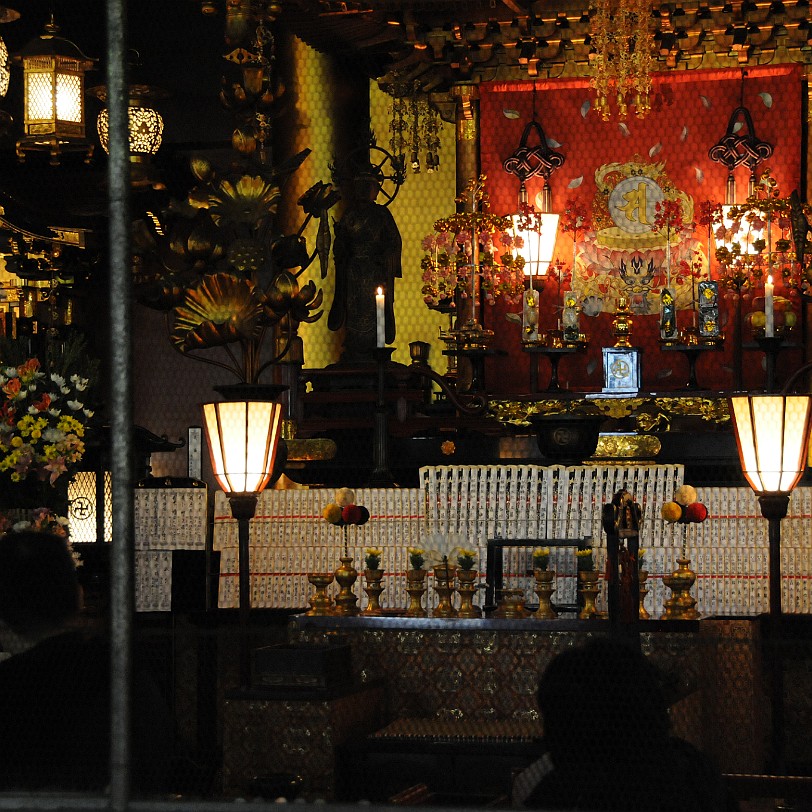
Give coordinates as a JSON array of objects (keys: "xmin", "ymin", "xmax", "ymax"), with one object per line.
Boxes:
[{"xmin": 420, "ymin": 178, "xmax": 524, "ymax": 309}]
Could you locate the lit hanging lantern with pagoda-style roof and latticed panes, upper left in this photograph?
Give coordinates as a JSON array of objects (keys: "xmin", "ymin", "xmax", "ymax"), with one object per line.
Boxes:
[{"xmin": 14, "ymin": 15, "xmax": 96, "ymax": 166}]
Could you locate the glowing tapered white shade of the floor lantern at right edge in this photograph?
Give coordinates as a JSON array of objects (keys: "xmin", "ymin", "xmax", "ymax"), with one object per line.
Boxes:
[{"xmin": 730, "ymin": 395, "xmax": 812, "ymax": 494}]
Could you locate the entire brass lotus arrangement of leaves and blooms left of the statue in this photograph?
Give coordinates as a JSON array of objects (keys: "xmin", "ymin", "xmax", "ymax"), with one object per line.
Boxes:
[{"xmin": 133, "ymin": 151, "xmax": 338, "ymax": 383}]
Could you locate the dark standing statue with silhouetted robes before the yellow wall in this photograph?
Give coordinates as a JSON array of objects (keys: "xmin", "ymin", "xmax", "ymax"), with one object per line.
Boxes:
[{"xmin": 327, "ymin": 165, "xmax": 402, "ymax": 363}]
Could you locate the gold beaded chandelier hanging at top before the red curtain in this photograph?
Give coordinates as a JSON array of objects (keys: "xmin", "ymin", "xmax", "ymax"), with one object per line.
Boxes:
[{"xmin": 589, "ymin": 0, "xmax": 654, "ymax": 121}]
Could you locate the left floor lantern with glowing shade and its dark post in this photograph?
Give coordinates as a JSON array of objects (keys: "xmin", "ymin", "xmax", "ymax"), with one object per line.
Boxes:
[{"xmin": 203, "ymin": 400, "xmax": 283, "ymax": 687}]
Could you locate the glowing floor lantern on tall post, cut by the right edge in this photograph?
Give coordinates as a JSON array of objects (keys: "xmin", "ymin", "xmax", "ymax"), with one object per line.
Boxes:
[{"xmin": 730, "ymin": 372, "xmax": 812, "ymax": 771}]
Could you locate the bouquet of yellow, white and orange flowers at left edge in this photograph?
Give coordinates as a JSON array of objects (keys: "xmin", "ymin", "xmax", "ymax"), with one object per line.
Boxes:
[{"xmin": 0, "ymin": 344, "xmax": 93, "ymax": 485}]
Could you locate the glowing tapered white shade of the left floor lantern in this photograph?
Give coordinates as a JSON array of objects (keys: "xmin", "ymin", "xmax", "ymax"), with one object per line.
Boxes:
[{"xmin": 203, "ymin": 400, "xmax": 283, "ymax": 493}]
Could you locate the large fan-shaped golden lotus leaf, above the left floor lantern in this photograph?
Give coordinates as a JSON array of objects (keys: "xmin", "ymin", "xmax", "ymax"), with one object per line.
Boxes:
[{"xmin": 172, "ymin": 273, "xmax": 267, "ymax": 350}]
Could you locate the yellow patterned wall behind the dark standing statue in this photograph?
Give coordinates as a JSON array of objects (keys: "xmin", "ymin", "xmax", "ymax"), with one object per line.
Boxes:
[{"xmin": 286, "ymin": 46, "xmax": 456, "ymax": 372}]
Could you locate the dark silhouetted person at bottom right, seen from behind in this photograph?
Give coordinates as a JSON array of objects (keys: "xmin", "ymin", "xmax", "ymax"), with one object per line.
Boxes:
[{"xmin": 523, "ymin": 638, "xmax": 736, "ymax": 812}]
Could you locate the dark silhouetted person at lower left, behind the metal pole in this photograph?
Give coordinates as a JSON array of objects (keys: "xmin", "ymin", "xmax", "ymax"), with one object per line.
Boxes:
[{"xmin": 0, "ymin": 531, "xmax": 172, "ymax": 793}]
